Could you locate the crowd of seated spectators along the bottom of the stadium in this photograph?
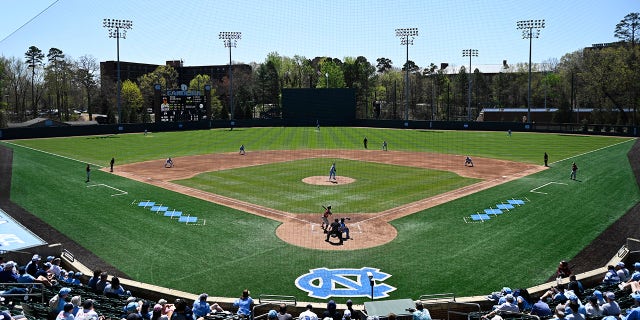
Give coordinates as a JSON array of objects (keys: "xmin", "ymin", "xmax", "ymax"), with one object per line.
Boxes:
[{"xmin": 0, "ymin": 254, "xmax": 640, "ymax": 320}]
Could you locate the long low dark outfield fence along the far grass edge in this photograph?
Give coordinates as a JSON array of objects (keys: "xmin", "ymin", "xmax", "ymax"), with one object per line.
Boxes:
[{"xmin": 0, "ymin": 118, "xmax": 639, "ymax": 140}]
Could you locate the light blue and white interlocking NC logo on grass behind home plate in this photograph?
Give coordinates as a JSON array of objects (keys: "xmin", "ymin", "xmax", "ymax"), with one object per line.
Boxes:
[{"xmin": 296, "ymin": 267, "xmax": 396, "ymax": 299}]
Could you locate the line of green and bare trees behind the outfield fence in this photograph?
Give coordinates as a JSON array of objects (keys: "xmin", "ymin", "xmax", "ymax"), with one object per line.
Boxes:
[{"xmin": 0, "ymin": 13, "xmax": 640, "ymax": 127}]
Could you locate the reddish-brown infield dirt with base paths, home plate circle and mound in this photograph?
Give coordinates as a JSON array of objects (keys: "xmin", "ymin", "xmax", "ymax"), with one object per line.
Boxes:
[{"xmin": 112, "ymin": 150, "xmax": 545, "ymax": 250}]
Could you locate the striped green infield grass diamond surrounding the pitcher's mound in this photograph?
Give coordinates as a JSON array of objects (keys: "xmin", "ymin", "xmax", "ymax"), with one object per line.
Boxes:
[{"xmin": 174, "ymin": 159, "xmax": 480, "ymax": 214}]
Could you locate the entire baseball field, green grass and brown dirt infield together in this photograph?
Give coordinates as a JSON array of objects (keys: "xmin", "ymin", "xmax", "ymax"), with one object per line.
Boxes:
[{"xmin": 1, "ymin": 127, "xmax": 640, "ymax": 301}]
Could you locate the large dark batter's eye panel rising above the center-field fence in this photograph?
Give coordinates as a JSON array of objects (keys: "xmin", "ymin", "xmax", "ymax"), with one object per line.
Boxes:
[{"xmin": 282, "ymin": 88, "xmax": 356, "ymax": 126}]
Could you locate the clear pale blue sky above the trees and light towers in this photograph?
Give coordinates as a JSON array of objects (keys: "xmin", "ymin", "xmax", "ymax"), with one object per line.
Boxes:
[{"xmin": 0, "ymin": 0, "xmax": 640, "ymax": 72}]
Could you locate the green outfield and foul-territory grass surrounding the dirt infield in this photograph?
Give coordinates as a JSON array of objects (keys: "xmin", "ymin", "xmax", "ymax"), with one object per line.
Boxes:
[{"xmin": 2, "ymin": 128, "xmax": 640, "ymax": 303}]
